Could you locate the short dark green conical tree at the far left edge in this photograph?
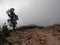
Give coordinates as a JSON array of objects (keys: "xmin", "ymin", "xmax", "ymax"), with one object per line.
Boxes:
[{"xmin": 0, "ymin": 23, "xmax": 9, "ymax": 43}]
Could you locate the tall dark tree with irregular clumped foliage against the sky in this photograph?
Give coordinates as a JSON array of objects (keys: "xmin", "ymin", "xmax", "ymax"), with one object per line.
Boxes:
[{"xmin": 6, "ymin": 8, "xmax": 19, "ymax": 30}]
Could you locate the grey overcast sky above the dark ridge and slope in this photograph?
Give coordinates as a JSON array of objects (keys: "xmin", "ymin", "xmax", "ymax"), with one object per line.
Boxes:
[{"xmin": 0, "ymin": 0, "xmax": 60, "ymax": 26}]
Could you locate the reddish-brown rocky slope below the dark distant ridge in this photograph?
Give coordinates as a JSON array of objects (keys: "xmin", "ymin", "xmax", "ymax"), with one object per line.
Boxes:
[{"xmin": 7, "ymin": 25, "xmax": 60, "ymax": 45}]
